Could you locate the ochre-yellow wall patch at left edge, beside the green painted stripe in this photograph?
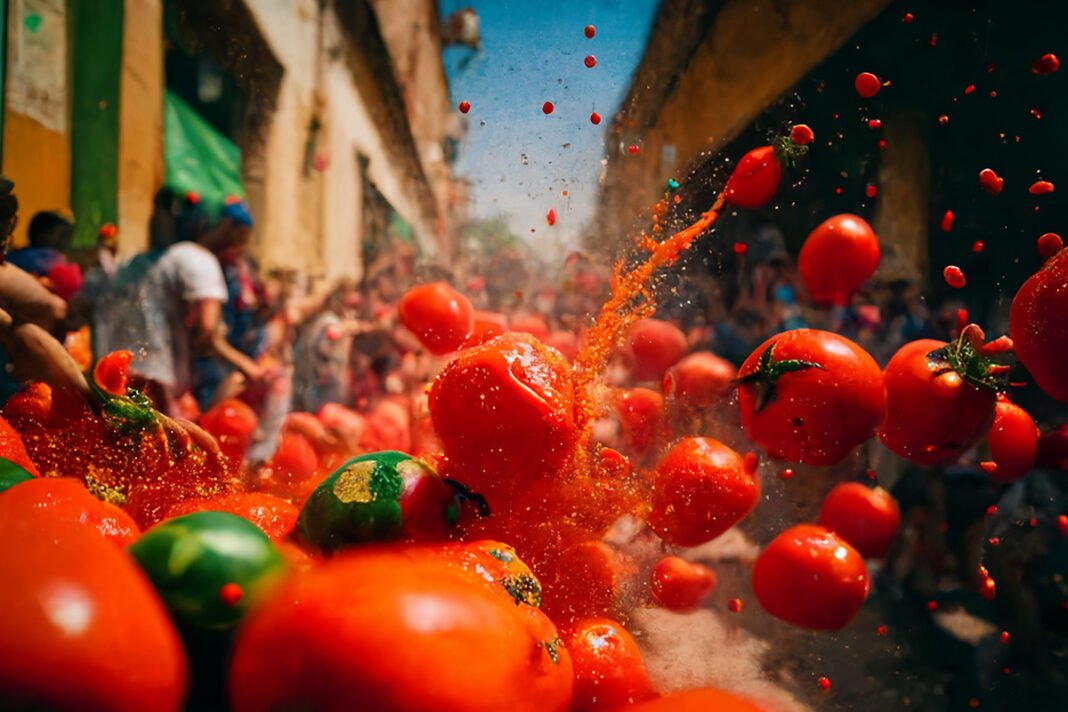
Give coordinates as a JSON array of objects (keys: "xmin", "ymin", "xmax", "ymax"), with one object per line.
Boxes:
[{"xmin": 3, "ymin": 109, "xmax": 70, "ymax": 247}]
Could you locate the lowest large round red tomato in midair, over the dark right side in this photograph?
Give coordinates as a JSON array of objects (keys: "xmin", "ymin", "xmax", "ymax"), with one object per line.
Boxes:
[{"xmin": 753, "ymin": 524, "xmax": 868, "ymax": 630}]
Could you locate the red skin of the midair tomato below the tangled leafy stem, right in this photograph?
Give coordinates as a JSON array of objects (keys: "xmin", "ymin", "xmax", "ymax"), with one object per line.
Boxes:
[{"xmin": 879, "ymin": 338, "xmax": 996, "ymax": 464}]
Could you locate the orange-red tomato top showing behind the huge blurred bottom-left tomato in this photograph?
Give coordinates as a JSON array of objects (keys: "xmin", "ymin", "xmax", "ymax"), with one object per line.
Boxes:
[{"xmin": 3, "ymin": 477, "xmax": 141, "ymax": 547}]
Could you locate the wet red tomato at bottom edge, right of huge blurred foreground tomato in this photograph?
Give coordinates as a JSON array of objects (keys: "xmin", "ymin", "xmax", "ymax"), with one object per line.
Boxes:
[{"xmin": 564, "ymin": 617, "xmax": 655, "ymax": 712}]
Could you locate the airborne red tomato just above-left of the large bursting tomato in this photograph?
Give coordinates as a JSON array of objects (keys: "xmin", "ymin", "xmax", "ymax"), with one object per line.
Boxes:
[{"xmin": 397, "ymin": 282, "xmax": 473, "ymax": 354}]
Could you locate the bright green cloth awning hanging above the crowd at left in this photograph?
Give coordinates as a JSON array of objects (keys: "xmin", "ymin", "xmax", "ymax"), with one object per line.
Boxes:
[{"xmin": 163, "ymin": 92, "xmax": 245, "ymax": 208}]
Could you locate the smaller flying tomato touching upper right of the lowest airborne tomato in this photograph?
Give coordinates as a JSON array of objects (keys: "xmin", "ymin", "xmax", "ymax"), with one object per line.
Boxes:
[{"xmin": 819, "ymin": 482, "xmax": 901, "ymax": 558}]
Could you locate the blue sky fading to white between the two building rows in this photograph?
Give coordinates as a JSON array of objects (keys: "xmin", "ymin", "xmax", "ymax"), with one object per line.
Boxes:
[{"xmin": 440, "ymin": 0, "xmax": 657, "ymax": 259}]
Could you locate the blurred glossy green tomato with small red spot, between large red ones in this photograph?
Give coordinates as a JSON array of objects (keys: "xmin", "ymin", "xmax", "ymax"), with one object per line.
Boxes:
[{"xmin": 129, "ymin": 511, "xmax": 285, "ymax": 628}]
